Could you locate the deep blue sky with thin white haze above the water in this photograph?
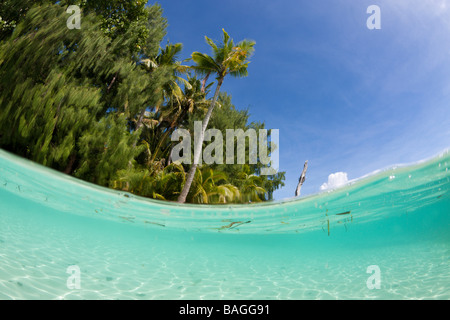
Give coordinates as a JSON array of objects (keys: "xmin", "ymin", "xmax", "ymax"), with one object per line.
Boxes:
[{"xmin": 154, "ymin": 0, "xmax": 450, "ymax": 200}]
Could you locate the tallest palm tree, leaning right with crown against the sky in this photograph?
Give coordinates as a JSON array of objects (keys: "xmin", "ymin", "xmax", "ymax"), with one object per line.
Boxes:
[{"xmin": 178, "ymin": 29, "xmax": 255, "ymax": 203}]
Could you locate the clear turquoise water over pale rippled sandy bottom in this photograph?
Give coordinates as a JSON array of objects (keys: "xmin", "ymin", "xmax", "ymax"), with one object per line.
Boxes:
[{"xmin": 0, "ymin": 150, "xmax": 450, "ymax": 300}]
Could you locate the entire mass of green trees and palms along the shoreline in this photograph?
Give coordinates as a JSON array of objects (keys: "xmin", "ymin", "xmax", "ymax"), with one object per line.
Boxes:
[{"xmin": 0, "ymin": 0, "xmax": 285, "ymax": 204}]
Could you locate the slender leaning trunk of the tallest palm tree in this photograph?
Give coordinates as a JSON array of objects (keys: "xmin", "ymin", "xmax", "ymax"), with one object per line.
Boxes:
[{"xmin": 177, "ymin": 78, "xmax": 223, "ymax": 203}]
